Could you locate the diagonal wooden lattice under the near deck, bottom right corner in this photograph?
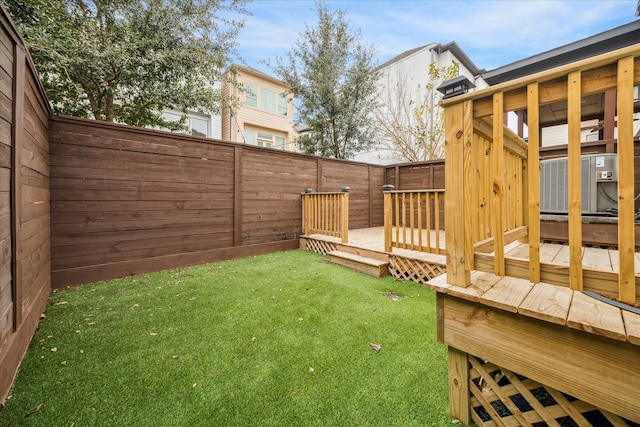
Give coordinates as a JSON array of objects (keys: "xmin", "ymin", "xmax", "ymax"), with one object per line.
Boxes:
[{"xmin": 468, "ymin": 355, "xmax": 638, "ymax": 427}]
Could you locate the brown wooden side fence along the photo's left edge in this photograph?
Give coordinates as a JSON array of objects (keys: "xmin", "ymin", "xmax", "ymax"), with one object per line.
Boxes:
[{"xmin": 0, "ymin": 5, "xmax": 51, "ymax": 406}]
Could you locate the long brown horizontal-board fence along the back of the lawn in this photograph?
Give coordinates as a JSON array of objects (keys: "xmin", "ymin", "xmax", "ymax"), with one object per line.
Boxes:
[{"xmin": 49, "ymin": 117, "xmax": 384, "ymax": 287}]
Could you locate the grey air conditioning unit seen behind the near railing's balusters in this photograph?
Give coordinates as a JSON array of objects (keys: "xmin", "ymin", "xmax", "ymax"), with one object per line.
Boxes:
[{"xmin": 540, "ymin": 154, "xmax": 618, "ymax": 215}]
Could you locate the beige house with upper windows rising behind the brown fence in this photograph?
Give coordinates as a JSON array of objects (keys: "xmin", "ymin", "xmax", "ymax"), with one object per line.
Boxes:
[{"xmin": 222, "ymin": 65, "xmax": 299, "ymax": 151}]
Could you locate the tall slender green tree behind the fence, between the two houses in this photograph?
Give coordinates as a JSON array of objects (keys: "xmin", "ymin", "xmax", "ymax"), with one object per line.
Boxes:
[{"xmin": 273, "ymin": 3, "xmax": 377, "ymax": 159}]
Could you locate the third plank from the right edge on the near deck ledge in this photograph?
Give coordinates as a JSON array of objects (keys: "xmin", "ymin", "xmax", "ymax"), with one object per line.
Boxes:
[{"xmin": 518, "ymin": 283, "xmax": 573, "ymax": 325}]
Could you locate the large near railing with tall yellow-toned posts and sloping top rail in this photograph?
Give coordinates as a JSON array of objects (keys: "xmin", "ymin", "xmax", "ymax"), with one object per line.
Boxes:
[{"xmin": 443, "ymin": 44, "xmax": 640, "ymax": 303}]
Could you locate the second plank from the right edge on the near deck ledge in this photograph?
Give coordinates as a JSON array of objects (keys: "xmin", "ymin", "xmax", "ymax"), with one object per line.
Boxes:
[{"xmin": 567, "ymin": 292, "xmax": 627, "ymax": 341}]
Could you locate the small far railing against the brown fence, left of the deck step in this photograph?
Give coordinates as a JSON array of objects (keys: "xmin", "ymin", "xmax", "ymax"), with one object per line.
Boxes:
[{"xmin": 302, "ymin": 191, "xmax": 349, "ymax": 243}]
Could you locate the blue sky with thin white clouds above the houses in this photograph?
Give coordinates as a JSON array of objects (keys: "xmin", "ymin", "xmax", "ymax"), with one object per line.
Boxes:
[{"xmin": 229, "ymin": 0, "xmax": 640, "ymax": 75}]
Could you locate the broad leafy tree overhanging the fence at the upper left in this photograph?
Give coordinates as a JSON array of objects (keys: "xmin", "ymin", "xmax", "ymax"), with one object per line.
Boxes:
[{"xmin": 4, "ymin": 0, "xmax": 248, "ymax": 129}]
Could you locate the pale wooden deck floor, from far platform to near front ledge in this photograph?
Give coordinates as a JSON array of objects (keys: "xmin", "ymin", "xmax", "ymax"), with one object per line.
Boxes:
[{"xmin": 307, "ymin": 227, "xmax": 640, "ymax": 345}]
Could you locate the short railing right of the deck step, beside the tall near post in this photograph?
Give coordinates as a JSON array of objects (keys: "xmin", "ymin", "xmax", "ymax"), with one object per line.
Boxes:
[{"xmin": 384, "ymin": 190, "xmax": 444, "ymax": 254}]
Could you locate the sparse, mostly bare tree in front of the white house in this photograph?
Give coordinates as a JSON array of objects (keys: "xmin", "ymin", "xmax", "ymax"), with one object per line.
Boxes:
[{"xmin": 373, "ymin": 62, "xmax": 460, "ymax": 162}]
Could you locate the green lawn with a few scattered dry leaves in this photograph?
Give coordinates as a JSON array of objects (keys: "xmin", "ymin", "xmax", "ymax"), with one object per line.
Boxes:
[{"xmin": 0, "ymin": 250, "xmax": 451, "ymax": 426}]
